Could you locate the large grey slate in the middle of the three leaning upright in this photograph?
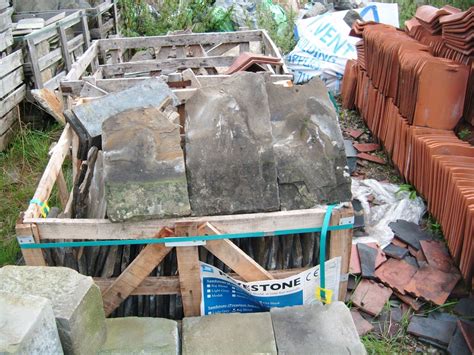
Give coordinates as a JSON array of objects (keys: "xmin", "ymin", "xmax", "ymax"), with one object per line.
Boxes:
[{"xmin": 185, "ymin": 73, "xmax": 280, "ymax": 215}]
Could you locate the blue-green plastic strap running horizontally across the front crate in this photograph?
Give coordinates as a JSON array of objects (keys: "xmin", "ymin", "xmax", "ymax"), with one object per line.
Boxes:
[{"xmin": 20, "ymin": 221, "xmax": 353, "ymax": 249}]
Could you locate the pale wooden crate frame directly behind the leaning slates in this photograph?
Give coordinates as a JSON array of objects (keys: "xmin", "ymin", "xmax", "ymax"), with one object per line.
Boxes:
[{"xmin": 60, "ymin": 30, "xmax": 293, "ymax": 97}]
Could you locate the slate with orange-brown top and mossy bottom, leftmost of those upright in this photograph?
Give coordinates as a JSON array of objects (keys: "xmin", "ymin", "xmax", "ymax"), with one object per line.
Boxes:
[{"xmin": 102, "ymin": 108, "xmax": 191, "ymax": 221}]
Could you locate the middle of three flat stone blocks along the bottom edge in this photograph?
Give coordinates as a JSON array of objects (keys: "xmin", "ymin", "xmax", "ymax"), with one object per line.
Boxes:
[{"xmin": 182, "ymin": 312, "xmax": 277, "ymax": 355}]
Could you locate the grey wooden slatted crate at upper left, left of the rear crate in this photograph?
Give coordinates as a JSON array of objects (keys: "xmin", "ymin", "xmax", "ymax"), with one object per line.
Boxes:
[{"xmin": 18, "ymin": 10, "xmax": 90, "ymax": 90}]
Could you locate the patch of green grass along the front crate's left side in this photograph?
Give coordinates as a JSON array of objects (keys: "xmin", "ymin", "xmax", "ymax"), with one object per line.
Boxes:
[{"xmin": 0, "ymin": 124, "xmax": 62, "ymax": 266}]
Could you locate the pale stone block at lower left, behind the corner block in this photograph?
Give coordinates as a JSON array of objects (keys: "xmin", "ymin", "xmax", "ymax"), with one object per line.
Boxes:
[{"xmin": 0, "ymin": 266, "xmax": 105, "ymax": 354}]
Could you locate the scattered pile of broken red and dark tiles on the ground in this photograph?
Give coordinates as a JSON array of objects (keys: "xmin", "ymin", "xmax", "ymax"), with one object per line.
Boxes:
[{"xmin": 346, "ymin": 220, "xmax": 474, "ymax": 354}]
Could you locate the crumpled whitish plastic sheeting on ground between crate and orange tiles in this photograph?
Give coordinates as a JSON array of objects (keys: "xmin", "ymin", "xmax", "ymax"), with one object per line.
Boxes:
[{"xmin": 352, "ymin": 179, "xmax": 426, "ymax": 248}]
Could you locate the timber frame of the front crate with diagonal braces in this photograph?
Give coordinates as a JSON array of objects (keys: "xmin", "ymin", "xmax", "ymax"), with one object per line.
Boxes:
[{"xmin": 16, "ymin": 124, "xmax": 353, "ymax": 316}]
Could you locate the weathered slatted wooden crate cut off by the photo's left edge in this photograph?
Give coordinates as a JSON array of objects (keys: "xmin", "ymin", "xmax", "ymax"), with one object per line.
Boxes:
[{"xmin": 0, "ymin": 51, "xmax": 26, "ymax": 151}]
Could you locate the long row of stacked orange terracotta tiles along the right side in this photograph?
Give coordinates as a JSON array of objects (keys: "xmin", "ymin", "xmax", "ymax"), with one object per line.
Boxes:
[{"xmin": 342, "ymin": 23, "xmax": 474, "ymax": 282}]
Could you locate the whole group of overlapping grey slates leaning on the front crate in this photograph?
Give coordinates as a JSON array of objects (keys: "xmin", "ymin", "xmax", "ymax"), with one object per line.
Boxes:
[{"xmin": 65, "ymin": 72, "xmax": 351, "ymax": 222}]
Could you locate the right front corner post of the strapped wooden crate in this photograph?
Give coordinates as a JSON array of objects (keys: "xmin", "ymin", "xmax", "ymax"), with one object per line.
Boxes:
[{"xmin": 329, "ymin": 206, "xmax": 354, "ymax": 302}]
